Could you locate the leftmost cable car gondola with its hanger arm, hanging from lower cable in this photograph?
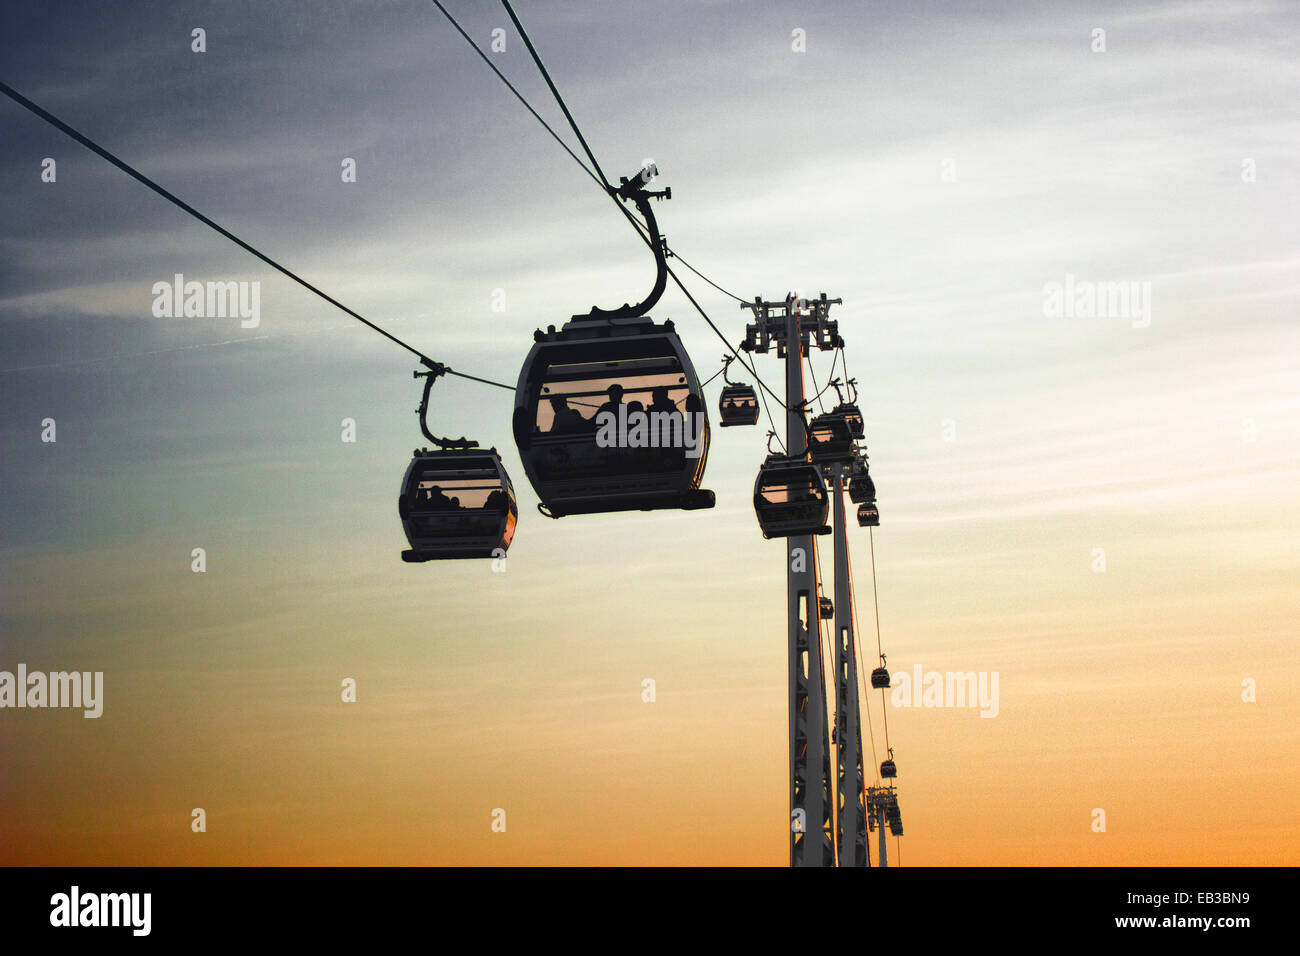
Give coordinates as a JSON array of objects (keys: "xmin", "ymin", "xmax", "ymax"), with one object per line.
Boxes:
[{"xmin": 398, "ymin": 363, "xmax": 519, "ymax": 562}]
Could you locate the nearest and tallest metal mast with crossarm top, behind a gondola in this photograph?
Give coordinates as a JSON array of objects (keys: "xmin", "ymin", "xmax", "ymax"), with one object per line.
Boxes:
[{"xmin": 741, "ymin": 293, "xmax": 844, "ymax": 866}]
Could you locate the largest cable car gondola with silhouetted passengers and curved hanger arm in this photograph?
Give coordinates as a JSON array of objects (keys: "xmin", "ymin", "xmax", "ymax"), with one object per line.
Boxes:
[{"xmin": 514, "ymin": 168, "xmax": 714, "ymax": 518}]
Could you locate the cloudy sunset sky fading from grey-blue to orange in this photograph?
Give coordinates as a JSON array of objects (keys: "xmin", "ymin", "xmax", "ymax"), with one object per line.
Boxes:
[{"xmin": 0, "ymin": 0, "xmax": 1300, "ymax": 865}]
